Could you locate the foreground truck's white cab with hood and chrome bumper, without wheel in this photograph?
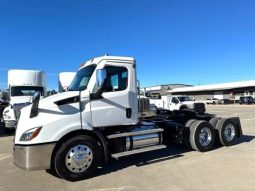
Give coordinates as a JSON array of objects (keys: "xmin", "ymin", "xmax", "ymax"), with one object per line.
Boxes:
[{"xmin": 14, "ymin": 56, "xmax": 138, "ymax": 176}]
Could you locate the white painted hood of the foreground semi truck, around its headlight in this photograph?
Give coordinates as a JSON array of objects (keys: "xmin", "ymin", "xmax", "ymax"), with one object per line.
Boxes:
[{"xmin": 15, "ymin": 92, "xmax": 81, "ymax": 144}]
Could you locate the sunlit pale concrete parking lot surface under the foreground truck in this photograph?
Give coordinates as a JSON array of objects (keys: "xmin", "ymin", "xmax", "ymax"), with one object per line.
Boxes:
[{"xmin": 0, "ymin": 105, "xmax": 255, "ymax": 191}]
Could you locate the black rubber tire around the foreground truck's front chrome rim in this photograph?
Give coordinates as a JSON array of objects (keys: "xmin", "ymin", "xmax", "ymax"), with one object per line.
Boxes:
[{"xmin": 54, "ymin": 135, "xmax": 101, "ymax": 181}]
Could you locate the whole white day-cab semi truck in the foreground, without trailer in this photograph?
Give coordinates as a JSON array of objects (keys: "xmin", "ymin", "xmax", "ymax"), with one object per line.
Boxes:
[{"xmin": 13, "ymin": 56, "xmax": 242, "ymax": 181}]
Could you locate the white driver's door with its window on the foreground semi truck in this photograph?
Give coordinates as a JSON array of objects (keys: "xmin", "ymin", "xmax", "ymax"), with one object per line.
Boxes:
[{"xmin": 91, "ymin": 65, "xmax": 134, "ymax": 127}]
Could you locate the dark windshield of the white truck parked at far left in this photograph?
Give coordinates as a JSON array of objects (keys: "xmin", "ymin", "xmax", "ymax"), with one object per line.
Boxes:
[{"xmin": 11, "ymin": 86, "xmax": 44, "ymax": 97}]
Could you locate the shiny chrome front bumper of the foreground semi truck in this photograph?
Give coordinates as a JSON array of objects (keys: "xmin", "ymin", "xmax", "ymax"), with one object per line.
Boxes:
[{"xmin": 13, "ymin": 143, "xmax": 56, "ymax": 171}]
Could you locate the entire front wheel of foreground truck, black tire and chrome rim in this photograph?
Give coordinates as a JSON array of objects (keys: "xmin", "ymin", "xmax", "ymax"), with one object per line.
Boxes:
[{"xmin": 54, "ymin": 135, "xmax": 100, "ymax": 181}]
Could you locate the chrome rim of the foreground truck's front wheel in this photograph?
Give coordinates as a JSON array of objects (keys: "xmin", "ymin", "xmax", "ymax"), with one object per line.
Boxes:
[{"xmin": 65, "ymin": 145, "xmax": 93, "ymax": 173}]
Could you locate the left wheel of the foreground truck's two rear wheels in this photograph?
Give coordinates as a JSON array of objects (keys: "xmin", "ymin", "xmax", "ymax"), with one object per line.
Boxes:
[{"xmin": 190, "ymin": 120, "xmax": 215, "ymax": 152}]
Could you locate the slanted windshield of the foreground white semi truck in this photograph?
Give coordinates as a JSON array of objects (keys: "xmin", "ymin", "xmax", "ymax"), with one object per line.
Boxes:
[{"xmin": 68, "ymin": 65, "xmax": 96, "ymax": 91}]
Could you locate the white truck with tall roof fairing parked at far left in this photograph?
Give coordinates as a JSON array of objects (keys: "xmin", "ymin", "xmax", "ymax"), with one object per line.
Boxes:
[{"xmin": 3, "ymin": 70, "xmax": 46, "ymax": 129}]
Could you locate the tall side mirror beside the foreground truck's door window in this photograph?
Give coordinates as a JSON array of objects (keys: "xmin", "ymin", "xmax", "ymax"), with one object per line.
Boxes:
[{"xmin": 90, "ymin": 69, "xmax": 106, "ymax": 99}]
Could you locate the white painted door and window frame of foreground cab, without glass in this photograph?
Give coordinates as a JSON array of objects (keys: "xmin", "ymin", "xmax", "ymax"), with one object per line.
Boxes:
[{"xmin": 91, "ymin": 61, "xmax": 137, "ymax": 127}]
